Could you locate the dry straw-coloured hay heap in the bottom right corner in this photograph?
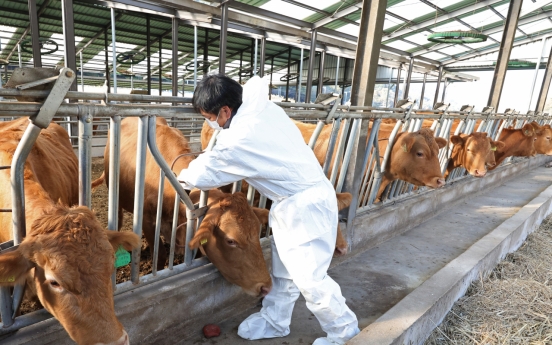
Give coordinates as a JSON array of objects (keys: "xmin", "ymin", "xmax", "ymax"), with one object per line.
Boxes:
[{"xmin": 425, "ymin": 216, "xmax": 552, "ymax": 345}]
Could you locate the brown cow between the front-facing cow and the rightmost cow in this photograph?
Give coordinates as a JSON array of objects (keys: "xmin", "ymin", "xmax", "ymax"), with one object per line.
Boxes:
[{"xmin": 489, "ymin": 123, "xmax": 537, "ymax": 170}]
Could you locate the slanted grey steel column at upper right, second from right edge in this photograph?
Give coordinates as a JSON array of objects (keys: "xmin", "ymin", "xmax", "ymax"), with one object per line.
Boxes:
[{"xmin": 487, "ymin": 0, "xmax": 523, "ymax": 110}]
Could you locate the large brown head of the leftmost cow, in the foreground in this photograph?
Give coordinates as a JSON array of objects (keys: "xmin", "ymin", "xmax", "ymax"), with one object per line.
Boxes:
[{"xmin": 0, "ymin": 206, "xmax": 140, "ymax": 345}]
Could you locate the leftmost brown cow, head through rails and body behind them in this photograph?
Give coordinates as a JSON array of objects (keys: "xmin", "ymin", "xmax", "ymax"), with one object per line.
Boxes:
[{"xmin": 0, "ymin": 118, "xmax": 139, "ymax": 345}]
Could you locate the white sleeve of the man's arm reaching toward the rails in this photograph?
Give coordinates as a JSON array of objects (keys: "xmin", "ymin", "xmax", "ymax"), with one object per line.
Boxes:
[{"xmin": 178, "ymin": 145, "xmax": 250, "ymax": 190}]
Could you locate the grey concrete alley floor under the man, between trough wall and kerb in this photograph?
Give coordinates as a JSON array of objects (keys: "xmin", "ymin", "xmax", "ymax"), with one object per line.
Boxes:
[{"xmin": 179, "ymin": 167, "xmax": 552, "ymax": 345}]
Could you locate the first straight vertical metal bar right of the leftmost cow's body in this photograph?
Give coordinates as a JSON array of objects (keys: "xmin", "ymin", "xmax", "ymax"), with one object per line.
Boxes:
[{"xmin": 79, "ymin": 105, "xmax": 94, "ymax": 207}]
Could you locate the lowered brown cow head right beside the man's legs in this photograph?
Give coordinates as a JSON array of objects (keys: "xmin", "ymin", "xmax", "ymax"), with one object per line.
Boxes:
[{"xmin": 190, "ymin": 189, "xmax": 272, "ymax": 296}]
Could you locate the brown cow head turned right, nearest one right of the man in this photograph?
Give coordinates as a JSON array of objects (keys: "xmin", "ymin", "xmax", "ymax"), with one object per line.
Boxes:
[{"xmin": 389, "ymin": 128, "xmax": 447, "ymax": 188}]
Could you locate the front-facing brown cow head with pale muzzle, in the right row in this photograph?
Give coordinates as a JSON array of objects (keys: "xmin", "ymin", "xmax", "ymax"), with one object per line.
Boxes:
[{"xmin": 450, "ymin": 132, "xmax": 504, "ymax": 177}]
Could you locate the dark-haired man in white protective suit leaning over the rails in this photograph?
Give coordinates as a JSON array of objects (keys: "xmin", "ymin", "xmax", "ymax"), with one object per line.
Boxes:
[{"xmin": 178, "ymin": 74, "xmax": 359, "ymax": 345}]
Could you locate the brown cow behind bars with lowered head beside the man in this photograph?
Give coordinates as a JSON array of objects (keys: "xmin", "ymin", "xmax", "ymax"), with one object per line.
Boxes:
[{"xmin": 93, "ymin": 117, "xmax": 272, "ymax": 295}]
